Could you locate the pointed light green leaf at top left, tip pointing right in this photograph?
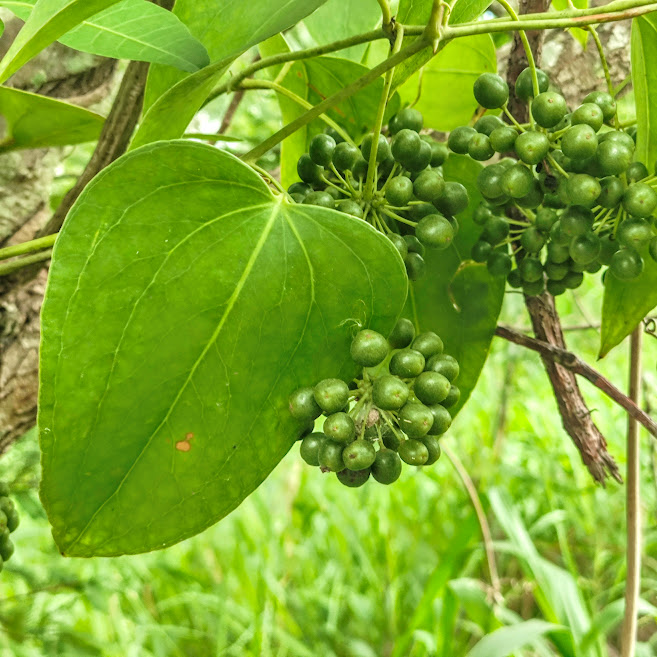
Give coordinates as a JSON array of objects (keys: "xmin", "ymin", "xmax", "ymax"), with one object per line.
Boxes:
[{"xmin": 0, "ymin": 0, "xmax": 210, "ymax": 72}]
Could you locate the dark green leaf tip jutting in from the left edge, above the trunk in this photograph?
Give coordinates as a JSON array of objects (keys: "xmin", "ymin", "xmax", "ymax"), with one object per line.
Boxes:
[{"xmin": 0, "ymin": 86, "xmax": 105, "ymax": 153}]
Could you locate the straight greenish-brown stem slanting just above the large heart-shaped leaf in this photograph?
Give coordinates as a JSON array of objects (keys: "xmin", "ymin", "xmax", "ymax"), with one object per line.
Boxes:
[{"xmin": 242, "ymin": 38, "xmax": 429, "ymax": 161}]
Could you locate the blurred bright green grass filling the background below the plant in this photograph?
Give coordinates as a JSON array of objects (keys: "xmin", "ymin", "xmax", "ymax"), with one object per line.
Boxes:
[{"xmin": 0, "ymin": 274, "xmax": 657, "ymax": 657}]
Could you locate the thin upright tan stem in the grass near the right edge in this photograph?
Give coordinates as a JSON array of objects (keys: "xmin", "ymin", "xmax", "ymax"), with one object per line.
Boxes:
[{"xmin": 621, "ymin": 327, "xmax": 642, "ymax": 657}]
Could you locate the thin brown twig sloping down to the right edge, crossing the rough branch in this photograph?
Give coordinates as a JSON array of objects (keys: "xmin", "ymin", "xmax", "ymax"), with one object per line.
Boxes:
[{"xmin": 495, "ymin": 326, "xmax": 657, "ymax": 438}]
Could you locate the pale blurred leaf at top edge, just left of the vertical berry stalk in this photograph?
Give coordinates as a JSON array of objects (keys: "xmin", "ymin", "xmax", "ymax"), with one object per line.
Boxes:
[{"xmin": 303, "ymin": 0, "xmax": 381, "ymax": 61}]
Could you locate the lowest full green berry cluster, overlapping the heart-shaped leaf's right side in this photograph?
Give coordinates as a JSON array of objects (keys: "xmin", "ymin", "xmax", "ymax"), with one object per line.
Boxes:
[{"xmin": 290, "ymin": 319, "xmax": 460, "ymax": 487}]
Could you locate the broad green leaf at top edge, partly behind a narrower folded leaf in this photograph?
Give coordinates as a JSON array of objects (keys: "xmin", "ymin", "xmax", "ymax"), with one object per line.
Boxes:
[{"xmin": 144, "ymin": 0, "xmax": 326, "ymax": 112}]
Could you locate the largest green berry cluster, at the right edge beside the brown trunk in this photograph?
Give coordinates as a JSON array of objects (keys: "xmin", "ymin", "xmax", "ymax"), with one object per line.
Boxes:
[{"xmin": 448, "ymin": 69, "xmax": 657, "ymax": 295}]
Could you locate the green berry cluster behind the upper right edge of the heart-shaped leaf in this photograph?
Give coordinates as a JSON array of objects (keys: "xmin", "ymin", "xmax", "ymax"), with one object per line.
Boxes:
[{"xmin": 288, "ymin": 108, "xmax": 468, "ymax": 280}]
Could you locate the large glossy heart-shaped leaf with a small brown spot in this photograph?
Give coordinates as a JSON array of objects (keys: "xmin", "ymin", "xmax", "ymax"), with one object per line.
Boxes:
[{"xmin": 39, "ymin": 141, "xmax": 407, "ymax": 556}]
